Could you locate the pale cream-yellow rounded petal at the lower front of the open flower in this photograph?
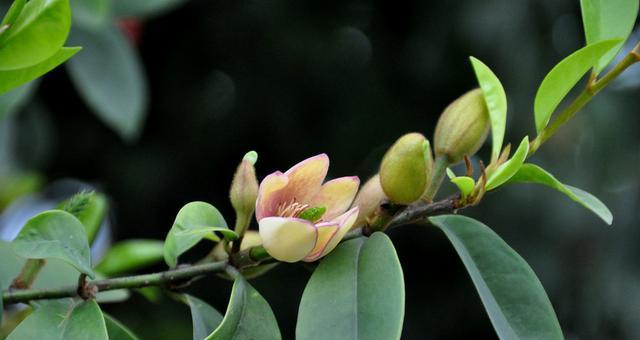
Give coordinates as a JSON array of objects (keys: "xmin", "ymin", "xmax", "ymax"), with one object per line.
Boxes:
[{"xmin": 258, "ymin": 217, "xmax": 318, "ymax": 262}]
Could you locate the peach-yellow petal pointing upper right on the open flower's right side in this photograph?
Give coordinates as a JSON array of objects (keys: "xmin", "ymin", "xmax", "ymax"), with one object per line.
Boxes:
[{"xmin": 309, "ymin": 176, "xmax": 360, "ymax": 221}]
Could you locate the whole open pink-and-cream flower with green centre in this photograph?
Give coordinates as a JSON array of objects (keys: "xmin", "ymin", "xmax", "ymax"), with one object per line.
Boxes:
[{"xmin": 256, "ymin": 154, "xmax": 360, "ymax": 262}]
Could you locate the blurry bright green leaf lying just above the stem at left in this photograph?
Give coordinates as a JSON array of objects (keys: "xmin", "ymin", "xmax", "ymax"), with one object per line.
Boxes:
[{"xmin": 95, "ymin": 240, "xmax": 164, "ymax": 276}]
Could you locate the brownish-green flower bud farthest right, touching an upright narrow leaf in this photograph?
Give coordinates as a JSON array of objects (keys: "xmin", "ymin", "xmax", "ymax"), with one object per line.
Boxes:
[{"xmin": 433, "ymin": 89, "xmax": 490, "ymax": 164}]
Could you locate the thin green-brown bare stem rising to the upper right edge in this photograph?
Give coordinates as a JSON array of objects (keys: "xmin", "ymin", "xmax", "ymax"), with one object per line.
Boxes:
[{"xmin": 527, "ymin": 43, "xmax": 640, "ymax": 157}]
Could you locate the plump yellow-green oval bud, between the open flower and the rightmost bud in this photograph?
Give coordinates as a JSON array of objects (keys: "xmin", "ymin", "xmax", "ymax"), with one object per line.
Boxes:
[{"xmin": 380, "ymin": 132, "xmax": 433, "ymax": 204}]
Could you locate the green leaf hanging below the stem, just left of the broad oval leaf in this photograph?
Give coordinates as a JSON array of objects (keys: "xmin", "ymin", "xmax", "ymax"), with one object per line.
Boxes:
[{"xmin": 206, "ymin": 276, "xmax": 282, "ymax": 340}]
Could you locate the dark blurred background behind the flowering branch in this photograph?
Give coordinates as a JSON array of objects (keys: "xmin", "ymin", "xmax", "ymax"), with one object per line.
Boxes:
[{"xmin": 0, "ymin": 0, "xmax": 640, "ymax": 339}]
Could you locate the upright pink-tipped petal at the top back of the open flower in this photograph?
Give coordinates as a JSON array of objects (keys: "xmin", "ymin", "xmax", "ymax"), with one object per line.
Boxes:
[{"xmin": 280, "ymin": 153, "xmax": 329, "ymax": 203}]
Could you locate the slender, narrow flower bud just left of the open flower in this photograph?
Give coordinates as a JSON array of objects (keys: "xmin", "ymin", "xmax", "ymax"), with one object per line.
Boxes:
[{"xmin": 229, "ymin": 151, "xmax": 258, "ymax": 235}]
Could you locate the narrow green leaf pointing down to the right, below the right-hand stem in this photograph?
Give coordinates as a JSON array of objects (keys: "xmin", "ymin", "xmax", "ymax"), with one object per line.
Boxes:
[{"xmin": 509, "ymin": 164, "xmax": 613, "ymax": 225}]
